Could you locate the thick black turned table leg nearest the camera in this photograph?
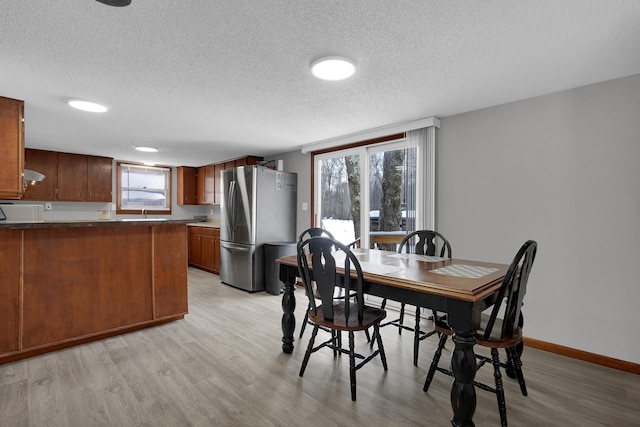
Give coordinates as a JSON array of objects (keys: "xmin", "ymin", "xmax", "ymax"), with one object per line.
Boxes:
[{"xmin": 451, "ymin": 333, "xmax": 476, "ymax": 427}]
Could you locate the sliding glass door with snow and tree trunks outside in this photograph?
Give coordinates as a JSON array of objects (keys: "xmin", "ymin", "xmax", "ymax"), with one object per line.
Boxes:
[{"xmin": 314, "ymin": 138, "xmax": 422, "ymax": 250}]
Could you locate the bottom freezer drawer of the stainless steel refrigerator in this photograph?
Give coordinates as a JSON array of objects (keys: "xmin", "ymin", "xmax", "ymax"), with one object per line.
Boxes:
[{"xmin": 220, "ymin": 242, "xmax": 264, "ymax": 292}]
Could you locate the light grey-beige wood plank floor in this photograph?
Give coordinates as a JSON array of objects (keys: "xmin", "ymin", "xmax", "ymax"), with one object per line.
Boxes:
[{"xmin": 0, "ymin": 268, "xmax": 640, "ymax": 427}]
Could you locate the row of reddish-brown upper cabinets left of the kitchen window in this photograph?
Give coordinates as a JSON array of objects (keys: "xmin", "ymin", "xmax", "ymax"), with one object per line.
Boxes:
[{"xmin": 23, "ymin": 149, "xmax": 113, "ymax": 202}]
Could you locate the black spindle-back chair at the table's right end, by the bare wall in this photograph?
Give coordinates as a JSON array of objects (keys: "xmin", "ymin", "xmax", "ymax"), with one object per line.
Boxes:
[{"xmin": 423, "ymin": 240, "xmax": 538, "ymax": 426}]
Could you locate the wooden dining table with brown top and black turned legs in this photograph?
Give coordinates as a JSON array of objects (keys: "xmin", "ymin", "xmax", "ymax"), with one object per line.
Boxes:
[{"xmin": 277, "ymin": 248, "xmax": 509, "ymax": 427}]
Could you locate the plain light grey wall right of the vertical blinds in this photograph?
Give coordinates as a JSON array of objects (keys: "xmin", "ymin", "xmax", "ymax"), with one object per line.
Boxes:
[{"xmin": 436, "ymin": 75, "xmax": 640, "ymax": 363}]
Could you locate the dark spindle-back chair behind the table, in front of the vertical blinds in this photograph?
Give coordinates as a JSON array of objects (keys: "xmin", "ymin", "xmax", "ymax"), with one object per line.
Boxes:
[{"xmin": 381, "ymin": 230, "xmax": 452, "ymax": 366}]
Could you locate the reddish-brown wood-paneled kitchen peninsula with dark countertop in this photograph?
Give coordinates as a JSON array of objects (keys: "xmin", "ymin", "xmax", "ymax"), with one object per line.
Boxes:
[{"xmin": 0, "ymin": 219, "xmax": 189, "ymax": 363}]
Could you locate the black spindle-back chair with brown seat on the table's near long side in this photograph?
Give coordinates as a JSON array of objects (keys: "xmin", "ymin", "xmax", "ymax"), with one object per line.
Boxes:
[{"xmin": 298, "ymin": 237, "xmax": 387, "ymax": 400}]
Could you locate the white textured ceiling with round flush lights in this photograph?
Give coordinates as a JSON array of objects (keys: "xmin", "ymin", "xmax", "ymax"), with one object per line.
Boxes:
[{"xmin": 0, "ymin": 0, "xmax": 640, "ymax": 166}]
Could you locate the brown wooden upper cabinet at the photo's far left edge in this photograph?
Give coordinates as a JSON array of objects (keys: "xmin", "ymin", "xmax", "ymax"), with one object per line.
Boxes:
[{"xmin": 0, "ymin": 97, "xmax": 24, "ymax": 199}]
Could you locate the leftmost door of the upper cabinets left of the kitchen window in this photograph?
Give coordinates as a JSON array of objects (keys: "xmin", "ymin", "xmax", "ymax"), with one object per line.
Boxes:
[{"xmin": 22, "ymin": 148, "xmax": 58, "ymax": 200}]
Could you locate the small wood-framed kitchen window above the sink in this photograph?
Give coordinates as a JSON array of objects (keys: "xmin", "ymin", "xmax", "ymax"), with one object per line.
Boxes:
[{"xmin": 116, "ymin": 163, "xmax": 171, "ymax": 215}]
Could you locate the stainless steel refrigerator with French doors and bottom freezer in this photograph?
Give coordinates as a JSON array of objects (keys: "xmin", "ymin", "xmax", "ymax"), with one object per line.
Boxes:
[{"xmin": 220, "ymin": 166, "xmax": 297, "ymax": 292}]
